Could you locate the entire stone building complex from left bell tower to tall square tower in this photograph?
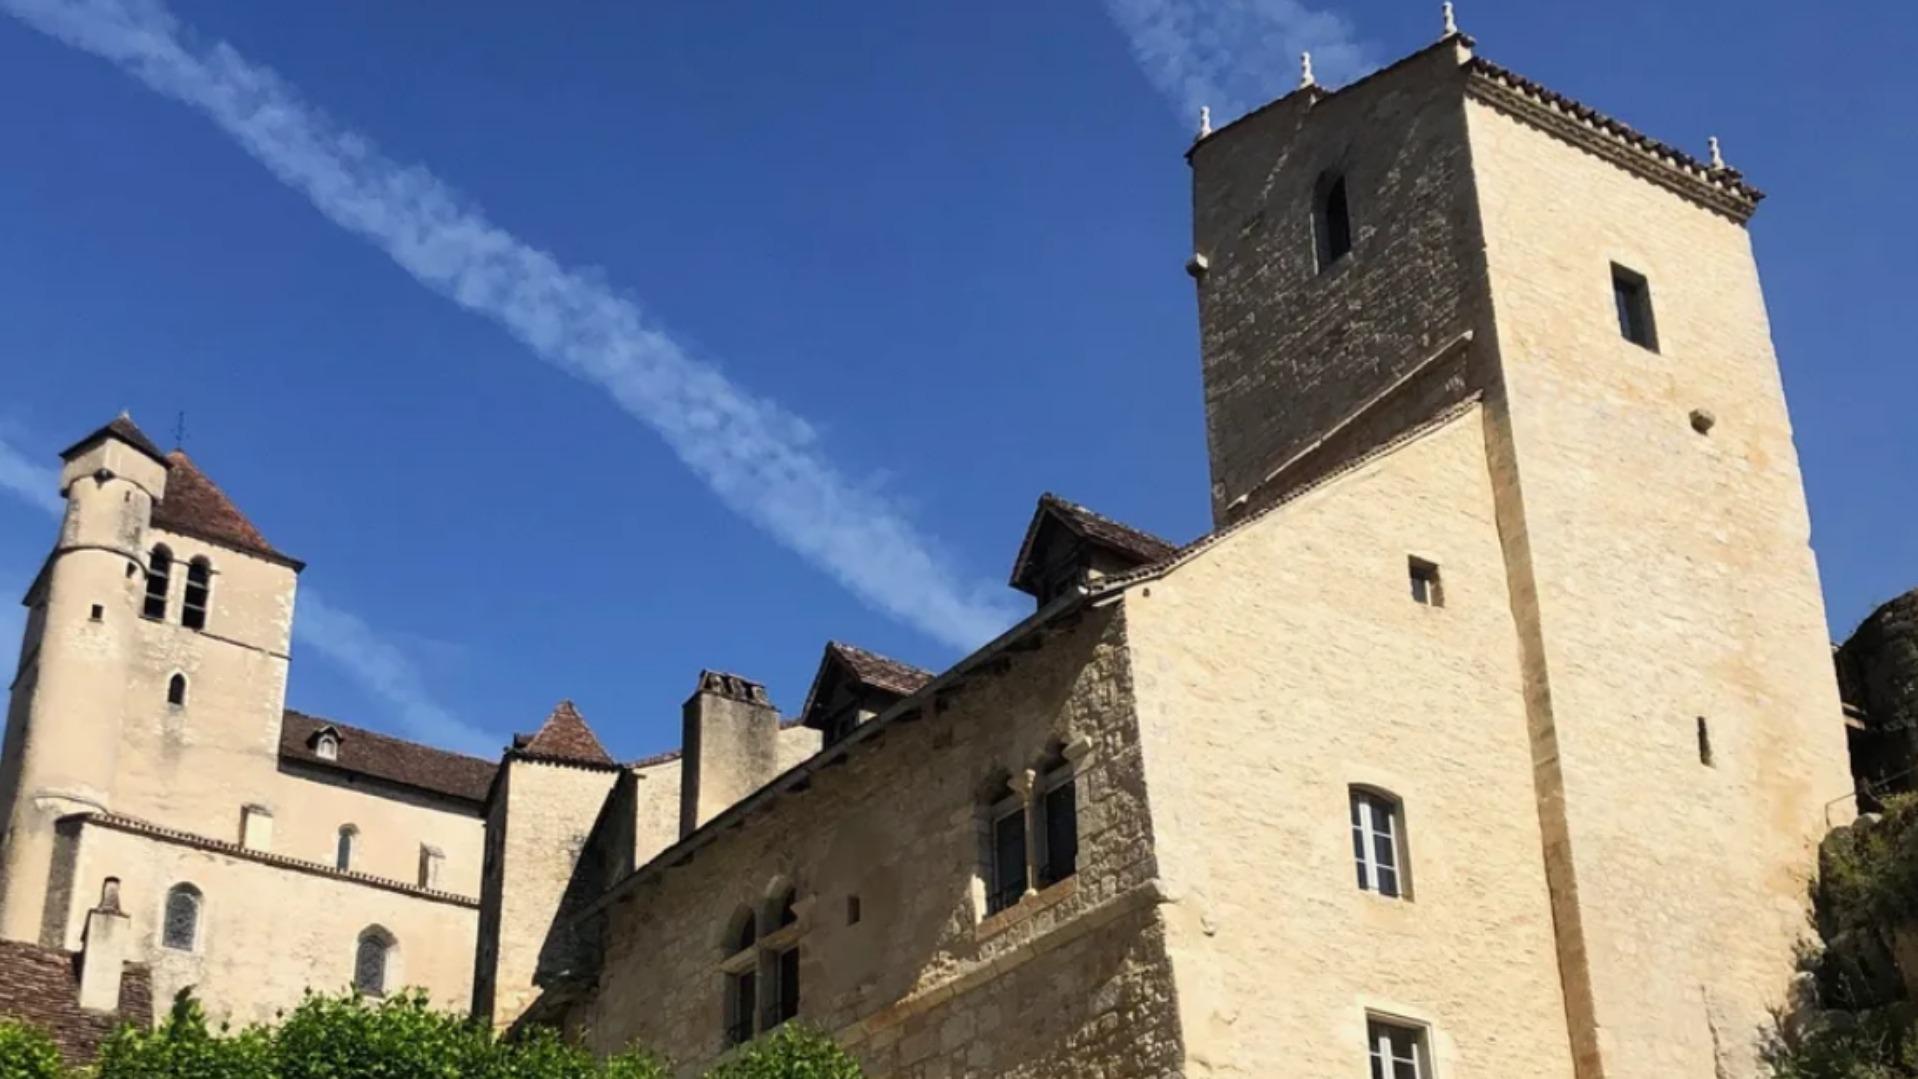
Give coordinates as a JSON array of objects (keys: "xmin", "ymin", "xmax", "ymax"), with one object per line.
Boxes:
[{"xmin": 0, "ymin": 19, "xmax": 1879, "ymax": 1079}]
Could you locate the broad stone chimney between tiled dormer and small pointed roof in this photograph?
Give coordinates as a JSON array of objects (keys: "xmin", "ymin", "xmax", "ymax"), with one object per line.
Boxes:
[{"xmin": 679, "ymin": 671, "xmax": 779, "ymax": 838}]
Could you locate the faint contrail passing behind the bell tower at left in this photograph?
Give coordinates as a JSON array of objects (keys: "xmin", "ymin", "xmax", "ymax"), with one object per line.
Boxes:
[{"xmin": 0, "ymin": 439, "xmax": 501, "ymax": 757}]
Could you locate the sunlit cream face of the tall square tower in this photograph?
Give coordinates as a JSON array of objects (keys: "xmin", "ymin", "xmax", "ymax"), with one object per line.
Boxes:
[{"xmin": 1467, "ymin": 90, "xmax": 1851, "ymax": 1077}]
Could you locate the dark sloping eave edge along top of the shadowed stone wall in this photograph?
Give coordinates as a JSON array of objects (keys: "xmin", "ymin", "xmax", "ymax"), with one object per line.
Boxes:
[{"xmin": 573, "ymin": 586, "xmax": 1103, "ymax": 922}]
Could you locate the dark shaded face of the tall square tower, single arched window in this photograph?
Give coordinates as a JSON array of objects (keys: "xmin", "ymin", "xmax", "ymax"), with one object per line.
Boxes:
[{"xmin": 1191, "ymin": 46, "xmax": 1483, "ymax": 523}]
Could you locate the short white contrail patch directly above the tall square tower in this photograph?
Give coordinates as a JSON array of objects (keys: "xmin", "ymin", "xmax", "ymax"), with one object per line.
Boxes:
[{"xmin": 1105, "ymin": 0, "xmax": 1375, "ymax": 121}]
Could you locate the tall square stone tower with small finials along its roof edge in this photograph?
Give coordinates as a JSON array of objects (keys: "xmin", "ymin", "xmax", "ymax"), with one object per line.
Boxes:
[{"xmin": 1189, "ymin": 33, "xmax": 1851, "ymax": 1077}]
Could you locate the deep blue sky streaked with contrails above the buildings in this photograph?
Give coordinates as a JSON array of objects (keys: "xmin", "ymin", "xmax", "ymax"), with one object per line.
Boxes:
[{"xmin": 0, "ymin": 0, "xmax": 1918, "ymax": 755}]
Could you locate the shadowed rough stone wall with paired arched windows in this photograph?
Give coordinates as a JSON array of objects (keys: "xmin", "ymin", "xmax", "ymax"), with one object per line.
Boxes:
[{"xmin": 573, "ymin": 609, "xmax": 1178, "ymax": 1079}]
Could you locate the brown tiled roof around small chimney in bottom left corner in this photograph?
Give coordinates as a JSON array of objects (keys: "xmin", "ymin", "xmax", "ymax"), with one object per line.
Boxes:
[{"xmin": 0, "ymin": 941, "xmax": 153, "ymax": 1066}]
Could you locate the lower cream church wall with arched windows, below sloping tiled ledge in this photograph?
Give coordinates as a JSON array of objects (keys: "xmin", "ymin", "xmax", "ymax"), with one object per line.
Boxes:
[{"xmin": 65, "ymin": 824, "xmax": 476, "ymax": 1022}]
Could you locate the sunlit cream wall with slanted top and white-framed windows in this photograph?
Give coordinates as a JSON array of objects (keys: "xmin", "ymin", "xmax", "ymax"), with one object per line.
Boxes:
[{"xmin": 1126, "ymin": 408, "xmax": 1571, "ymax": 1079}]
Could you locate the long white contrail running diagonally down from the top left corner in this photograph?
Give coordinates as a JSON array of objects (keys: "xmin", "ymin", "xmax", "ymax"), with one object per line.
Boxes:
[{"xmin": 0, "ymin": 0, "xmax": 1015, "ymax": 648}]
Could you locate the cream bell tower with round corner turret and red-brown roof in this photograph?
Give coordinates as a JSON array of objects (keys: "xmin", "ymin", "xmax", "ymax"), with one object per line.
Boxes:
[{"xmin": 0, "ymin": 416, "xmax": 301, "ymax": 945}]
